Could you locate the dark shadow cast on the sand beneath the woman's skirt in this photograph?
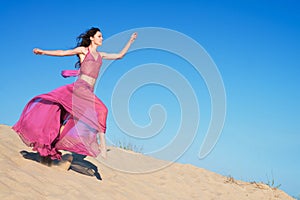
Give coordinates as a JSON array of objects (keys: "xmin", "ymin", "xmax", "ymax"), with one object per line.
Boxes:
[{"xmin": 20, "ymin": 150, "xmax": 102, "ymax": 180}]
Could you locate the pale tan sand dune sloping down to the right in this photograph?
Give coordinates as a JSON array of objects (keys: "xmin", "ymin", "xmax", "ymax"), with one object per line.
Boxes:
[{"xmin": 0, "ymin": 125, "xmax": 293, "ymax": 200}]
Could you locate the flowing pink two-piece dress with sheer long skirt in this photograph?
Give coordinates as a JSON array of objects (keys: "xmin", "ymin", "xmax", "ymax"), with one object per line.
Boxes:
[{"xmin": 12, "ymin": 52, "xmax": 107, "ymax": 159}]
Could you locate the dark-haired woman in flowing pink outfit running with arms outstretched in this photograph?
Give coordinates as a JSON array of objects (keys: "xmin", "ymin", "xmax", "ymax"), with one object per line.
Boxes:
[{"xmin": 13, "ymin": 27, "xmax": 137, "ymax": 164}]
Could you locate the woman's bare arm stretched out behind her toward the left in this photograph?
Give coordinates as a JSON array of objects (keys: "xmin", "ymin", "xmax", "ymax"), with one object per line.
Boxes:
[{"xmin": 33, "ymin": 47, "xmax": 86, "ymax": 56}]
